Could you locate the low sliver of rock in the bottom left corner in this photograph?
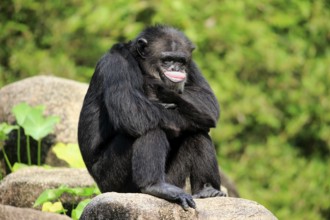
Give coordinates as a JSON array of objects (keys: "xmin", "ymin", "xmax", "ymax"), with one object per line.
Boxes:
[{"xmin": 0, "ymin": 205, "xmax": 71, "ymax": 220}]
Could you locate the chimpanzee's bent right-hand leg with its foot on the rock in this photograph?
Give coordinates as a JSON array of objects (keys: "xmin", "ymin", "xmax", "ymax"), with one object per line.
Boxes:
[{"xmin": 166, "ymin": 132, "xmax": 225, "ymax": 198}]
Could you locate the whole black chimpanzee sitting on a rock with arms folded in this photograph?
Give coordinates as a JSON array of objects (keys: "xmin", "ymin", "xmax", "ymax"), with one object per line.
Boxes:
[{"xmin": 78, "ymin": 26, "xmax": 225, "ymax": 209}]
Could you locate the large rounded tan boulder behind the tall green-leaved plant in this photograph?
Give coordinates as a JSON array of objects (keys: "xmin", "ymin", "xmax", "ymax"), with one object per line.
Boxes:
[{"xmin": 0, "ymin": 76, "xmax": 88, "ymax": 168}]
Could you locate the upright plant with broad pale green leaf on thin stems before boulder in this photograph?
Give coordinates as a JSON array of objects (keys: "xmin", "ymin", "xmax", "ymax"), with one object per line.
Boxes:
[{"xmin": 12, "ymin": 103, "xmax": 60, "ymax": 166}]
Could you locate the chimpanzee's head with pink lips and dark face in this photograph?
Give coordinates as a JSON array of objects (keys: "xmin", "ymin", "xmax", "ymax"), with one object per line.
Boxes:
[{"xmin": 133, "ymin": 26, "xmax": 195, "ymax": 93}]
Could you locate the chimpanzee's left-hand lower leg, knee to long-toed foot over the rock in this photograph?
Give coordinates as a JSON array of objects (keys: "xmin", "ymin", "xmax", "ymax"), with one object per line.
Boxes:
[{"xmin": 132, "ymin": 129, "xmax": 195, "ymax": 209}]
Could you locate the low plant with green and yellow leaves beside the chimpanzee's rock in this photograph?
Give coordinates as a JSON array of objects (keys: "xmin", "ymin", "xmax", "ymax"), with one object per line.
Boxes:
[{"xmin": 33, "ymin": 185, "xmax": 100, "ymax": 220}]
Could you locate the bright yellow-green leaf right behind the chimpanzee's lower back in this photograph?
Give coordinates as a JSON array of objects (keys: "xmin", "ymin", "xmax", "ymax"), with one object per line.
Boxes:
[{"xmin": 53, "ymin": 143, "xmax": 86, "ymax": 168}]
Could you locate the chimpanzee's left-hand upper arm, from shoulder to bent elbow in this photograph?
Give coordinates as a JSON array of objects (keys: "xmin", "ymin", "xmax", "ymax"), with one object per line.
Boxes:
[{"xmin": 97, "ymin": 44, "xmax": 164, "ymax": 136}]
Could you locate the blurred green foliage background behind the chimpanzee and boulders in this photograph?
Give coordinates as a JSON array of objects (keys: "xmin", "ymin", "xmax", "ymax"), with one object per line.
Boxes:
[{"xmin": 0, "ymin": 0, "xmax": 330, "ymax": 219}]
